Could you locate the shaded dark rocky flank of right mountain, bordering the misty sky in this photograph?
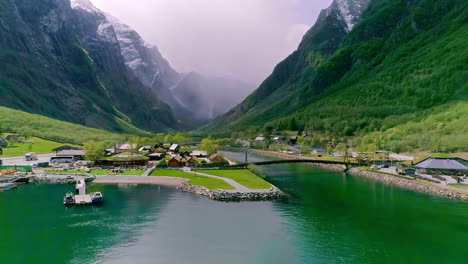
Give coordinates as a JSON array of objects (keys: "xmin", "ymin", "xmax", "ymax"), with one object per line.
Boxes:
[{"xmin": 204, "ymin": 0, "xmax": 369, "ymax": 127}]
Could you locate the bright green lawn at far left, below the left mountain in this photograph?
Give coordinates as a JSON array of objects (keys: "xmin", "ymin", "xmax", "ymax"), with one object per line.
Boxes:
[{"xmin": 0, "ymin": 134, "xmax": 80, "ymax": 158}]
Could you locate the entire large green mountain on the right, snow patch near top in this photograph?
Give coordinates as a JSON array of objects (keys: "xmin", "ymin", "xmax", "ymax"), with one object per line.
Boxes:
[{"xmin": 201, "ymin": 0, "xmax": 468, "ymax": 153}]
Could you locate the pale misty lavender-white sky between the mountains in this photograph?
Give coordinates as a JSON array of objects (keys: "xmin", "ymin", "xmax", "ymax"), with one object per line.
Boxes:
[{"xmin": 91, "ymin": 0, "xmax": 332, "ymax": 85}]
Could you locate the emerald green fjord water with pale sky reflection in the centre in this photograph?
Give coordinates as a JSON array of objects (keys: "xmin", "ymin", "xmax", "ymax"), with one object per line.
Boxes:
[{"xmin": 0, "ymin": 153, "xmax": 468, "ymax": 264}]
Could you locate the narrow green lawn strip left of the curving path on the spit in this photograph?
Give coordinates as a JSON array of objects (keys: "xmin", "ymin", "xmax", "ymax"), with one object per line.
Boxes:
[{"xmin": 151, "ymin": 170, "xmax": 235, "ymax": 190}]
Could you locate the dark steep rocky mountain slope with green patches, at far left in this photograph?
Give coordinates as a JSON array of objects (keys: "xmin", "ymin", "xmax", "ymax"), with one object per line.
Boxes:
[{"xmin": 0, "ymin": 0, "xmax": 180, "ymax": 131}]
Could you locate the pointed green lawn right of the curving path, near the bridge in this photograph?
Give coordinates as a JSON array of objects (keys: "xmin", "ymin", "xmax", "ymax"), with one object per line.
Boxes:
[{"xmin": 197, "ymin": 170, "xmax": 272, "ymax": 189}]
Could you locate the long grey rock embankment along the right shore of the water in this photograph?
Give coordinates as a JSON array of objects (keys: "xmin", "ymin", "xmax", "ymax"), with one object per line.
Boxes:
[{"xmin": 348, "ymin": 167, "xmax": 468, "ymax": 201}]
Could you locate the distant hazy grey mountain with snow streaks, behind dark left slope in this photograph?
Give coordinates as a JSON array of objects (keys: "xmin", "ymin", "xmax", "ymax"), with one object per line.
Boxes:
[{"xmin": 72, "ymin": 0, "xmax": 253, "ymax": 125}]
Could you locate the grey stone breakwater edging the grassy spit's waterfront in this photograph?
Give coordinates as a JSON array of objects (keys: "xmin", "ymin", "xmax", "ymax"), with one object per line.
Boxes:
[{"xmin": 177, "ymin": 183, "xmax": 286, "ymax": 201}]
